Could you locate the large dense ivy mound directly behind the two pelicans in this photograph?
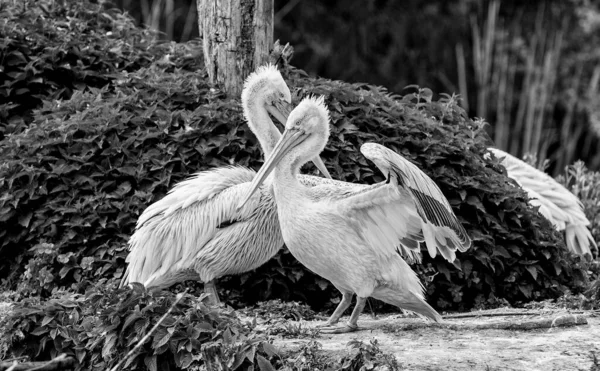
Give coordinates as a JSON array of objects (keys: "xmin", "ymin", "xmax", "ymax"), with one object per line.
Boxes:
[{"xmin": 0, "ymin": 0, "xmax": 586, "ymax": 309}]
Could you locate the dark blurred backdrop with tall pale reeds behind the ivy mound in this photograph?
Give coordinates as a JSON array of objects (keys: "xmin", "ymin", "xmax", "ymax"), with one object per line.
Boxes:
[{"xmin": 116, "ymin": 0, "xmax": 600, "ymax": 175}]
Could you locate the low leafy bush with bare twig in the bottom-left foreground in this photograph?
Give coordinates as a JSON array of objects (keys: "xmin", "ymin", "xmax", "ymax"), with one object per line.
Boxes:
[{"xmin": 0, "ymin": 282, "xmax": 275, "ymax": 370}]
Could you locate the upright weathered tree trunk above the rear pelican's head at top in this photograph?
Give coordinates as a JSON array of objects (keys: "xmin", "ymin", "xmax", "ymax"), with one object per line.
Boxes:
[{"xmin": 197, "ymin": 0, "xmax": 273, "ymax": 96}]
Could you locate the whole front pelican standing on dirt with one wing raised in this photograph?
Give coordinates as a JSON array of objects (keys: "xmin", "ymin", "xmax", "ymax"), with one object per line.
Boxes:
[{"xmin": 238, "ymin": 97, "xmax": 471, "ymax": 333}]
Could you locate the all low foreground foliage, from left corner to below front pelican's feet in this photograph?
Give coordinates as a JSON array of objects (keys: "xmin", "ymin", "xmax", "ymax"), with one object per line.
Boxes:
[{"xmin": 0, "ymin": 290, "xmax": 401, "ymax": 371}]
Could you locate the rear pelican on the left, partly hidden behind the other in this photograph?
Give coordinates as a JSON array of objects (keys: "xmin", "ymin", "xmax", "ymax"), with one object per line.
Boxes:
[{"xmin": 121, "ymin": 65, "xmax": 331, "ymax": 304}]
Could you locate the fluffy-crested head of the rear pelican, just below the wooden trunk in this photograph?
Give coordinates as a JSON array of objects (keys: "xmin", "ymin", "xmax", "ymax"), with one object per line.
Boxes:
[{"xmin": 242, "ymin": 64, "xmax": 292, "ymax": 130}]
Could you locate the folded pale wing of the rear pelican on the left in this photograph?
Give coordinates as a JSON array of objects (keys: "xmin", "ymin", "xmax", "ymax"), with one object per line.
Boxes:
[{"xmin": 122, "ymin": 167, "xmax": 260, "ymax": 287}]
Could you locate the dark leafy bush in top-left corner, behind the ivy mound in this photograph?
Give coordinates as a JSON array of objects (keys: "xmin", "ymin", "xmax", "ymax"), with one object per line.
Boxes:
[{"xmin": 0, "ymin": 0, "xmax": 198, "ymax": 139}]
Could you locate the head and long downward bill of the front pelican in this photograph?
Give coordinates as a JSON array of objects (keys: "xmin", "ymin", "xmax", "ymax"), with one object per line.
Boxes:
[{"xmin": 238, "ymin": 97, "xmax": 329, "ymax": 209}]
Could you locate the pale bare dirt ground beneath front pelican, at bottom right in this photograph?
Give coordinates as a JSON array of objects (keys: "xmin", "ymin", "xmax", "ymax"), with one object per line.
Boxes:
[{"xmin": 274, "ymin": 310, "xmax": 600, "ymax": 371}]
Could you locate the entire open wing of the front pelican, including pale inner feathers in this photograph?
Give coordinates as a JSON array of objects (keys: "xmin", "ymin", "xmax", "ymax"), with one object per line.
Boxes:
[{"xmin": 322, "ymin": 143, "xmax": 471, "ymax": 261}]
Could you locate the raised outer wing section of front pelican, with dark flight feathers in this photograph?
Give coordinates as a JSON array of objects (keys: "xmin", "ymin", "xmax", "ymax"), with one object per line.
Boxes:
[{"xmin": 360, "ymin": 143, "xmax": 471, "ymax": 261}]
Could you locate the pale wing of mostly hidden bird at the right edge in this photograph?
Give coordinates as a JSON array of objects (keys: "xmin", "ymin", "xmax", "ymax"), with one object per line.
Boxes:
[{"xmin": 488, "ymin": 148, "xmax": 598, "ymax": 258}]
